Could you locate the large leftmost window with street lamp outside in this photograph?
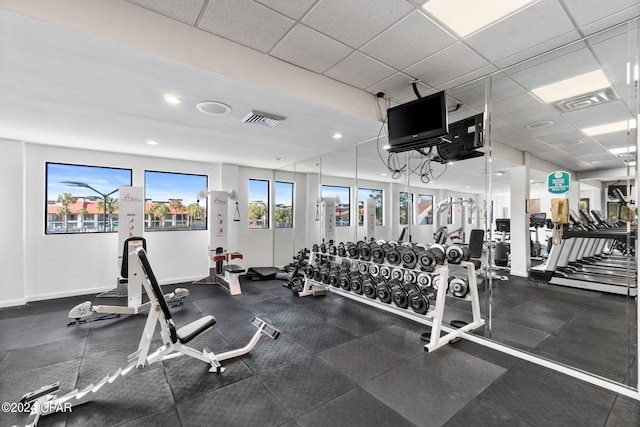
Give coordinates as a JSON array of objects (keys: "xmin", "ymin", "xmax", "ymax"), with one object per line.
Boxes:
[{"xmin": 45, "ymin": 162, "xmax": 132, "ymax": 234}]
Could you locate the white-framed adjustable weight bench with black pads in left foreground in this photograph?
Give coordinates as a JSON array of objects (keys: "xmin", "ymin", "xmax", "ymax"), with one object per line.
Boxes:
[{"xmin": 20, "ymin": 247, "xmax": 280, "ymax": 426}]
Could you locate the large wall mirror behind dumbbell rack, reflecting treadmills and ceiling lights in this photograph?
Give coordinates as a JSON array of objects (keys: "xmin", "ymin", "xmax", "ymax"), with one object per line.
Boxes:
[{"xmin": 275, "ymin": 21, "xmax": 638, "ymax": 389}]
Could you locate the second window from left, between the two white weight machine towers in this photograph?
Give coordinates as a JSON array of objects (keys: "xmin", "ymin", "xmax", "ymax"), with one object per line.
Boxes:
[{"xmin": 144, "ymin": 171, "xmax": 208, "ymax": 231}]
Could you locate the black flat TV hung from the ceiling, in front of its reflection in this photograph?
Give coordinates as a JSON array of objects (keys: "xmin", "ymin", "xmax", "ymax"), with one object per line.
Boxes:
[{"xmin": 387, "ymin": 92, "xmax": 449, "ymax": 153}]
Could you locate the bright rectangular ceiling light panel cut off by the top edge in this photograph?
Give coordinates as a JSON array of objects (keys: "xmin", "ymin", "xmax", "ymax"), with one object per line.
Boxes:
[{"xmin": 422, "ymin": 0, "xmax": 538, "ymax": 37}]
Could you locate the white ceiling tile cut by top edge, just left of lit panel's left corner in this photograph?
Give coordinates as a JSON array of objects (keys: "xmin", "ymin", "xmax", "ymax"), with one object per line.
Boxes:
[{"xmin": 302, "ymin": 0, "xmax": 413, "ymax": 48}]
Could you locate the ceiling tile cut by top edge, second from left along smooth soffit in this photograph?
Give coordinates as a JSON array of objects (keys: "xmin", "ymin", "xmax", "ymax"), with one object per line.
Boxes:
[{"xmin": 199, "ymin": 0, "xmax": 294, "ymax": 52}]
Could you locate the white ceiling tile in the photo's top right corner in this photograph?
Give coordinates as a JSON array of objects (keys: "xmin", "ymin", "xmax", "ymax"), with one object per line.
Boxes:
[{"xmin": 564, "ymin": 0, "xmax": 640, "ymax": 31}]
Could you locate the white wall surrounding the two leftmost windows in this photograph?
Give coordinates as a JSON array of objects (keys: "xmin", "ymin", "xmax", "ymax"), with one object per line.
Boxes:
[{"xmin": 0, "ymin": 141, "xmax": 219, "ymax": 306}]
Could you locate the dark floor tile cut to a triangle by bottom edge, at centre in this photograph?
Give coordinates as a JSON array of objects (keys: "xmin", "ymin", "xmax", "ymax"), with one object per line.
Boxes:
[{"xmin": 296, "ymin": 387, "xmax": 413, "ymax": 427}]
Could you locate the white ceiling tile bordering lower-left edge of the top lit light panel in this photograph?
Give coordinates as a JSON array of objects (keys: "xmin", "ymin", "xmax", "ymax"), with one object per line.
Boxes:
[{"xmin": 360, "ymin": 11, "xmax": 456, "ymax": 70}]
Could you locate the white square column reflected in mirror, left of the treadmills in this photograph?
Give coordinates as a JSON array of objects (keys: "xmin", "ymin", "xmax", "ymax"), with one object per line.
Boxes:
[{"xmin": 510, "ymin": 161, "xmax": 531, "ymax": 277}]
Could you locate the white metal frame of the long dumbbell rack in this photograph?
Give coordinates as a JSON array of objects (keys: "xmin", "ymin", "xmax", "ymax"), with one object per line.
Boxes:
[{"xmin": 298, "ymin": 252, "xmax": 485, "ymax": 352}]
